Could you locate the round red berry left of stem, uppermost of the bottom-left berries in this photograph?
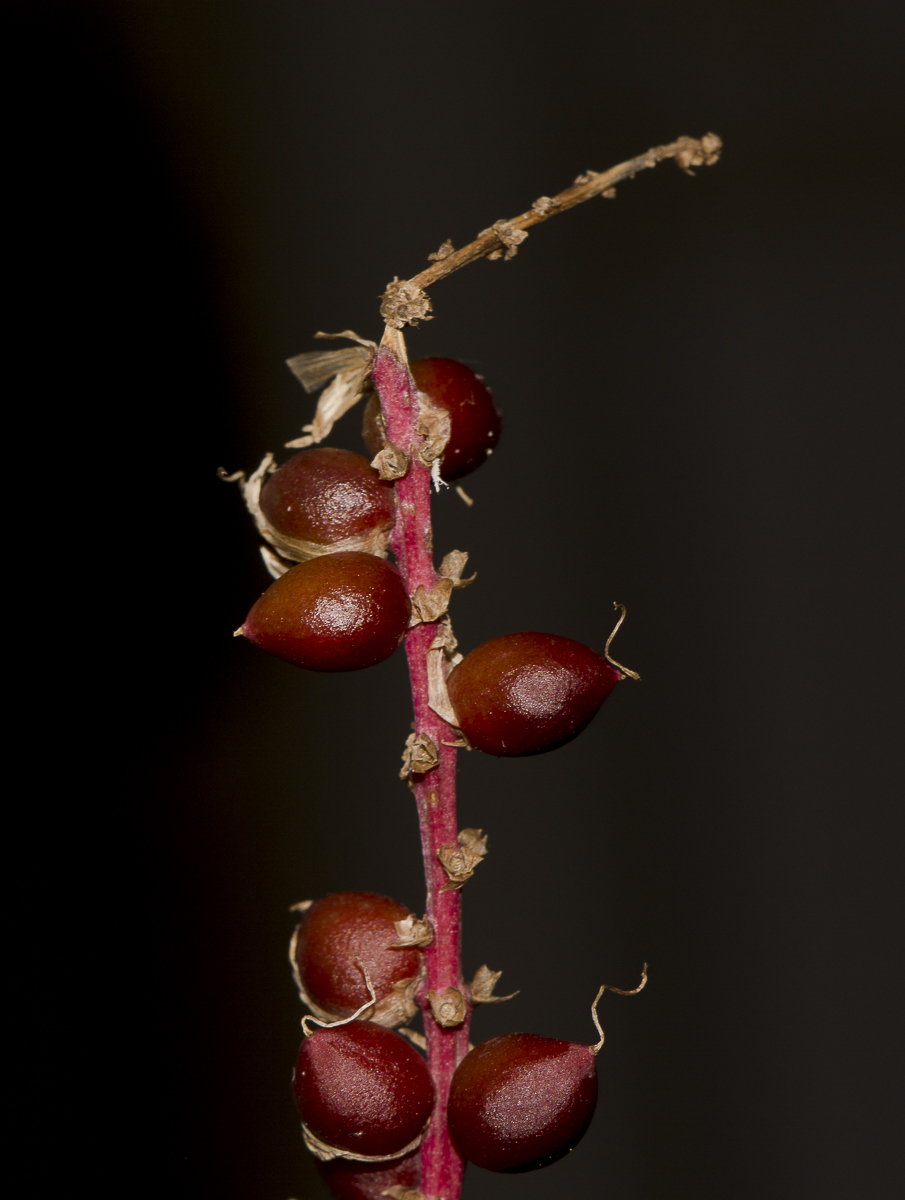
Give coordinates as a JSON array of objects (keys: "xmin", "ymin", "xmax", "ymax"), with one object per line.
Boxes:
[{"xmin": 295, "ymin": 892, "xmax": 421, "ymax": 1018}]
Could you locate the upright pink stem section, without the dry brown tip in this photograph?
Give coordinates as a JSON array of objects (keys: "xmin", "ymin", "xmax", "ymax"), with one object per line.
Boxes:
[{"xmin": 372, "ymin": 331, "xmax": 471, "ymax": 1200}]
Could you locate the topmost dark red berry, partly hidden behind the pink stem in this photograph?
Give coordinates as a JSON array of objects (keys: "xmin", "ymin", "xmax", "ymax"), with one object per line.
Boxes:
[{"xmin": 362, "ymin": 359, "xmax": 501, "ymax": 482}]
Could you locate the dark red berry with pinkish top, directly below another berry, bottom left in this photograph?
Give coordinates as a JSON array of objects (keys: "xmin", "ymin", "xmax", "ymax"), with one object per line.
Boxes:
[{"xmin": 293, "ymin": 1021, "xmax": 434, "ymax": 1158}]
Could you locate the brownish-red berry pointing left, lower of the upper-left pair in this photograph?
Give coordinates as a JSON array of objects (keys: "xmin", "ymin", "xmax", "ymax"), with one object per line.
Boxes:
[{"xmin": 241, "ymin": 550, "xmax": 412, "ymax": 671}]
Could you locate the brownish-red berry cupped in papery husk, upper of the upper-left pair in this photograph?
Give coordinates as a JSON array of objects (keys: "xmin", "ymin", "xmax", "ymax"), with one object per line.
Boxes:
[{"xmin": 260, "ymin": 446, "xmax": 396, "ymax": 546}]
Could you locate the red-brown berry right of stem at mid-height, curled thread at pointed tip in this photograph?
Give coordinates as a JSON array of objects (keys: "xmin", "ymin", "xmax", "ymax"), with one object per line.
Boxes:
[{"xmin": 446, "ymin": 634, "xmax": 622, "ymax": 757}]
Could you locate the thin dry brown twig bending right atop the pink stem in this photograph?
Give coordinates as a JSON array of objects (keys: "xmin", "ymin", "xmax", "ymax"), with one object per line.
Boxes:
[{"xmin": 380, "ymin": 133, "xmax": 723, "ymax": 329}]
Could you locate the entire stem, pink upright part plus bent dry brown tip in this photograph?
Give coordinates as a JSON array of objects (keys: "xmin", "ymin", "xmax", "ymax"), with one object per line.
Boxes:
[{"xmin": 362, "ymin": 133, "xmax": 723, "ymax": 1200}]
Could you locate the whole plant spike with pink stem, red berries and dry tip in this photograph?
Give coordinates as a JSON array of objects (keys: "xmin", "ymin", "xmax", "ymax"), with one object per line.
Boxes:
[{"xmin": 221, "ymin": 134, "xmax": 721, "ymax": 1200}]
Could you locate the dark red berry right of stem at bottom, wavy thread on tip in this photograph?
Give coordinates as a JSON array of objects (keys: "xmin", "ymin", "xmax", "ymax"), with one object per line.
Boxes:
[{"xmin": 448, "ymin": 1033, "xmax": 598, "ymax": 1174}]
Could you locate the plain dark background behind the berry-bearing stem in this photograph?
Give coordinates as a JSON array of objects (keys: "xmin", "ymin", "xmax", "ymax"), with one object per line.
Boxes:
[{"xmin": 17, "ymin": 0, "xmax": 905, "ymax": 1200}]
